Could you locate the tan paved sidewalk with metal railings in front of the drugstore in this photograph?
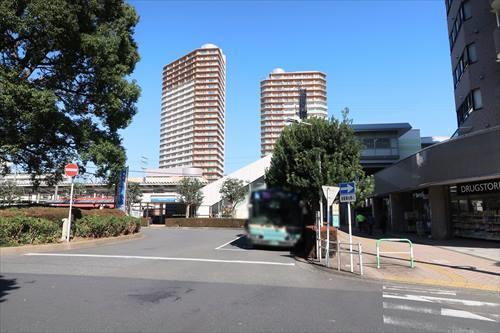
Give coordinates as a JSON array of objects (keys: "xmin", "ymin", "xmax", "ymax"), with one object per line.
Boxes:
[{"xmin": 331, "ymin": 231, "xmax": 500, "ymax": 292}]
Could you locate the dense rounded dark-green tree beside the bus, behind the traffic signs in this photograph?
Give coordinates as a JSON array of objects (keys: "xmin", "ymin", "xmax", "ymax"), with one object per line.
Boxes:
[{"xmin": 266, "ymin": 108, "xmax": 367, "ymax": 219}]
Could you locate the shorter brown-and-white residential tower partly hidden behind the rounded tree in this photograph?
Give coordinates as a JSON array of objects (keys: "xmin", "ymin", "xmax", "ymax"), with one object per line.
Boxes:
[{"xmin": 260, "ymin": 68, "xmax": 328, "ymax": 157}]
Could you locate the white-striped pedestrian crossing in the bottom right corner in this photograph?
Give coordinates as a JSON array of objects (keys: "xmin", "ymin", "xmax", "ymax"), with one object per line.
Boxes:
[{"xmin": 382, "ymin": 284, "xmax": 500, "ymax": 332}]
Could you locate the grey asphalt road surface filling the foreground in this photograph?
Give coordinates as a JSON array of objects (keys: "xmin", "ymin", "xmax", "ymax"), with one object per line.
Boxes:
[{"xmin": 0, "ymin": 228, "xmax": 500, "ymax": 332}]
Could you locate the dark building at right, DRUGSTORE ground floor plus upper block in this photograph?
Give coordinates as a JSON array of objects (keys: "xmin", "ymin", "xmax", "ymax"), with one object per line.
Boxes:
[{"xmin": 372, "ymin": 0, "xmax": 500, "ymax": 241}]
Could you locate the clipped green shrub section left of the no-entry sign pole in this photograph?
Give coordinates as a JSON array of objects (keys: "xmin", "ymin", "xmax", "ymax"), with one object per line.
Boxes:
[{"xmin": 0, "ymin": 216, "xmax": 62, "ymax": 246}]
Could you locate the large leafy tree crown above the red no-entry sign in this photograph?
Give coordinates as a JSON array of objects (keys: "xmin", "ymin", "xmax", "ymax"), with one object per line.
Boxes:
[{"xmin": 0, "ymin": 0, "xmax": 140, "ymax": 186}]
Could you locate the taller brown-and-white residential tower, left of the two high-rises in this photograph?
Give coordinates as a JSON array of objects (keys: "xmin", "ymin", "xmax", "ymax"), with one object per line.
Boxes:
[{"xmin": 160, "ymin": 44, "xmax": 226, "ymax": 181}]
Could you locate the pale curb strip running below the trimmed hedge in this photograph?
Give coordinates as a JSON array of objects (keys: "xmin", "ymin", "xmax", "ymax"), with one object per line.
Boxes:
[{"xmin": 0, "ymin": 232, "xmax": 144, "ymax": 257}]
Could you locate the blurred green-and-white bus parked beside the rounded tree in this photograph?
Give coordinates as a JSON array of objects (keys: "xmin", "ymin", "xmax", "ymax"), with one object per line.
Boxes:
[{"xmin": 245, "ymin": 189, "xmax": 304, "ymax": 248}]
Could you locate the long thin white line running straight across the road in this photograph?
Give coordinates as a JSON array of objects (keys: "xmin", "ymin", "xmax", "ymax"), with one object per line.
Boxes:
[{"xmin": 25, "ymin": 253, "xmax": 295, "ymax": 266}]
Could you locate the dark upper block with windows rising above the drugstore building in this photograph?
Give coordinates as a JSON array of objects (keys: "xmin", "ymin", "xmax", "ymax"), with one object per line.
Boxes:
[{"xmin": 445, "ymin": 0, "xmax": 500, "ymax": 135}]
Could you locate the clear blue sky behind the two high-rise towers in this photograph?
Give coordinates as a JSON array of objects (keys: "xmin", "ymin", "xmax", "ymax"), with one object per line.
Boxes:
[{"xmin": 122, "ymin": 0, "xmax": 456, "ymax": 175}]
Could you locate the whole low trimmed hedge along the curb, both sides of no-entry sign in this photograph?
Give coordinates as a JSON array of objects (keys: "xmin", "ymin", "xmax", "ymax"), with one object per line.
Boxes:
[{"xmin": 0, "ymin": 207, "xmax": 143, "ymax": 246}]
